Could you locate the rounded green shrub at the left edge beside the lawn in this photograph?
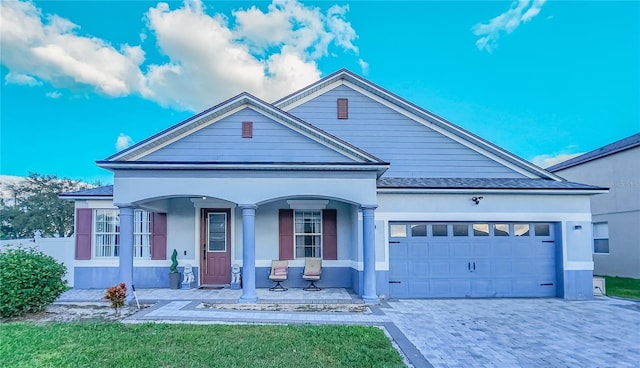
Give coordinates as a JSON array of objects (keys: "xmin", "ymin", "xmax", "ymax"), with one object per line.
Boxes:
[{"xmin": 0, "ymin": 248, "xmax": 68, "ymax": 317}]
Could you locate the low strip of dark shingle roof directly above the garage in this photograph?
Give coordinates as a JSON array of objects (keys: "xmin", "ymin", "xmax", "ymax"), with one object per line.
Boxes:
[{"xmin": 378, "ymin": 178, "xmax": 606, "ymax": 190}]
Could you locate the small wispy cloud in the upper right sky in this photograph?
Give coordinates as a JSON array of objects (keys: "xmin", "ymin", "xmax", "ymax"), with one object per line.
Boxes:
[{"xmin": 472, "ymin": 0, "xmax": 546, "ymax": 53}]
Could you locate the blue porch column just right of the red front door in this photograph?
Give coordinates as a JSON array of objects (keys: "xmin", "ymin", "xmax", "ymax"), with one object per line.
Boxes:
[{"xmin": 238, "ymin": 204, "xmax": 258, "ymax": 303}]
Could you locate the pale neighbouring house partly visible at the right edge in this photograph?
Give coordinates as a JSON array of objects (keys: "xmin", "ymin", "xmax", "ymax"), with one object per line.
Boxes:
[{"xmin": 547, "ymin": 133, "xmax": 640, "ymax": 279}]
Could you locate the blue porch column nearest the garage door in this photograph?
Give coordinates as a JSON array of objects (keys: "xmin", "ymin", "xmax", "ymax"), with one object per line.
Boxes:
[{"xmin": 362, "ymin": 205, "xmax": 380, "ymax": 304}]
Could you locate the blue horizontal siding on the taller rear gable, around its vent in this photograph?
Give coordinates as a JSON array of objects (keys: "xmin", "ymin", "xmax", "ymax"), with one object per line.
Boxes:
[{"xmin": 290, "ymin": 86, "xmax": 525, "ymax": 178}]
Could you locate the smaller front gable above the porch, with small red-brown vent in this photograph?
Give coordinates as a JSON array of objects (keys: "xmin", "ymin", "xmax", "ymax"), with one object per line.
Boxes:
[{"xmin": 104, "ymin": 93, "xmax": 384, "ymax": 166}]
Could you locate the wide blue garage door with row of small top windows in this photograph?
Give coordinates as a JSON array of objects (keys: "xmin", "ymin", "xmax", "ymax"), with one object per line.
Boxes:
[{"xmin": 389, "ymin": 222, "xmax": 557, "ymax": 298}]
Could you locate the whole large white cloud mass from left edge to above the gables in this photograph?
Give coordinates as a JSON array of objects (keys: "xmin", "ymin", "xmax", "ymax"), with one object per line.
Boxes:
[{"xmin": 0, "ymin": 0, "xmax": 368, "ymax": 111}]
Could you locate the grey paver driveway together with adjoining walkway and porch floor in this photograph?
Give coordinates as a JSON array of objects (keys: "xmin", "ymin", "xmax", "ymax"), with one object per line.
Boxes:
[{"xmin": 60, "ymin": 289, "xmax": 640, "ymax": 367}]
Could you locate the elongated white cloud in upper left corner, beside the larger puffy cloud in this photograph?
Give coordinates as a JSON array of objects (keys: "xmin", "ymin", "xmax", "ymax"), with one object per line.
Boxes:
[{"xmin": 0, "ymin": 1, "xmax": 144, "ymax": 96}]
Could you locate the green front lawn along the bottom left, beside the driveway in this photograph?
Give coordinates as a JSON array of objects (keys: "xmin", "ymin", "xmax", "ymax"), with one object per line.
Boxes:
[{"xmin": 0, "ymin": 322, "xmax": 404, "ymax": 368}]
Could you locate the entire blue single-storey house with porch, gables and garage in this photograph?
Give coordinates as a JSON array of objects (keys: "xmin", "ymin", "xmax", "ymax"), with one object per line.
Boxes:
[{"xmin": 61, "ymin": 70, "xmax": 606, "ymax": 302}]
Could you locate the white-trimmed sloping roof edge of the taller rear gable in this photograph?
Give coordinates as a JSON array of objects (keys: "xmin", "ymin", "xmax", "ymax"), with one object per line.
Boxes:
[{"xmin": 273, "ymin": 69, "xmax": 563, "ymax": 181}]
